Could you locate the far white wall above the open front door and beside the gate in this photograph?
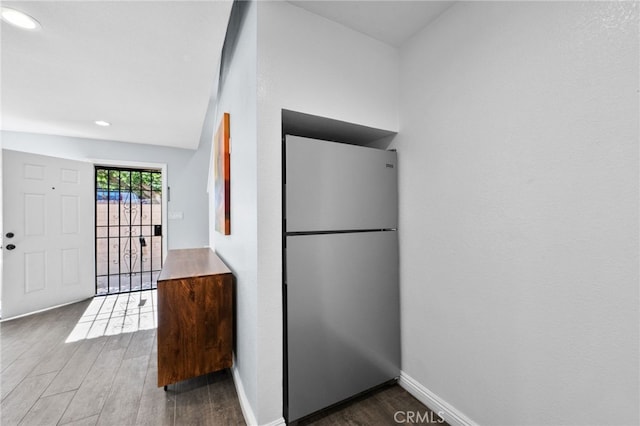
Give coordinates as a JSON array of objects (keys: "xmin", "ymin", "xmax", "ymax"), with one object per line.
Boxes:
[{"xmin": 1, "ymin": 131, "xmax": 209, "ymax": 249}]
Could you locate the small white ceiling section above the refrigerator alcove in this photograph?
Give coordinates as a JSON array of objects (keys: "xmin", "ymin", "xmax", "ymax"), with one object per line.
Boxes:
[{"xmin": 289, "ymin": 0, "xmax": 454, "ymax": 47}]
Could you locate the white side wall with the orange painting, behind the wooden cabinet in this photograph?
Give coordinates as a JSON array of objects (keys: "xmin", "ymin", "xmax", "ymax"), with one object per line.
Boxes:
[{"xmin": 209, "ymin": 3, "xmax": 260, "ymax": 423}]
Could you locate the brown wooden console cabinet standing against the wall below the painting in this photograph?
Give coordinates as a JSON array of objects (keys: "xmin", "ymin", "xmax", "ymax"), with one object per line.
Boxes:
[{"xmin": 158, "ymin": 248, "xmax": 233, "ymax": 390}]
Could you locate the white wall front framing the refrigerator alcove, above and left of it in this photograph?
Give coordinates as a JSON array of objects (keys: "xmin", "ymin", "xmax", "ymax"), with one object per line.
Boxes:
[{"xmin": 255, "ymin": 1, "xmax": 398, "ymax": 424}]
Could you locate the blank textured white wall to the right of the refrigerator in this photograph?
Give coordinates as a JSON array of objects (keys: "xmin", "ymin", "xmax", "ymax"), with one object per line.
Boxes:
[{"xmin": 395, "ymin": 2, "xmax": 640, "ymax": 425}]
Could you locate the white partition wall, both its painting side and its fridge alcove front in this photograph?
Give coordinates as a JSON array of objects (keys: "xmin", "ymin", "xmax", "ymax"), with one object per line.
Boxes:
[{"xmin": 212, "ymin": 2, "xmax": 398, "ymax": 424}]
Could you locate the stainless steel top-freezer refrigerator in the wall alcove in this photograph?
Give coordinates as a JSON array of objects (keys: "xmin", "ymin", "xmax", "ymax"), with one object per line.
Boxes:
[{"xmin": 283, "ymin": 136, "xmax": 400, "ymax": 422}]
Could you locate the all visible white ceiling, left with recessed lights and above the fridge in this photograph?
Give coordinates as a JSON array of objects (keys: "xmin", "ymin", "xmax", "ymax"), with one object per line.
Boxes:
[{"xmin": 0, "ymin": 0, "xmax": 452, "ymax": 149}]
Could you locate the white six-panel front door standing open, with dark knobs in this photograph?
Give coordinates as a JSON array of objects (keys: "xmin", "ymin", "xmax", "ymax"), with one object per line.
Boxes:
[{"xmin": 2, "ymin": 150, "xmax": 95, "ymax": 319}]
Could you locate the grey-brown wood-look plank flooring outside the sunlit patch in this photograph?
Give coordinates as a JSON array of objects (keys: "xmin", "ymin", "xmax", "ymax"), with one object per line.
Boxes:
[{"xmin": 0, "ymin": 293, "xmax": 446, "ymax": 426}]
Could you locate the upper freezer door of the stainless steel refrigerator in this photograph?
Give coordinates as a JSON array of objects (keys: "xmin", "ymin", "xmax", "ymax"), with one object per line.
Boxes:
[{"xmin": 285, "ymin": 136, "xmax": 398, "ymax": 232}]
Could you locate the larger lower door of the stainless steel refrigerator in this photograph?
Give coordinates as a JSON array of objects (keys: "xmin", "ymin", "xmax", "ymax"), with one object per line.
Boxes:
[{"xmin": 286, "ymin": 231, "xmax": 400, "ymax": 421}]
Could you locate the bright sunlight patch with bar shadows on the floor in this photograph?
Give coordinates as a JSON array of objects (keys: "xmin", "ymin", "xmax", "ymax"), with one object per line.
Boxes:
[{"xmin": 66, "ymin": 290, "xmax": 158, "ymax": 343}]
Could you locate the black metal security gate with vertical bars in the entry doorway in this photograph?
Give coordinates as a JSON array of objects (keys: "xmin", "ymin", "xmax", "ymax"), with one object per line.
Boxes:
[{"xmin": 95, "ymin": 166, "xmax": 162, "ymax": 295}]
